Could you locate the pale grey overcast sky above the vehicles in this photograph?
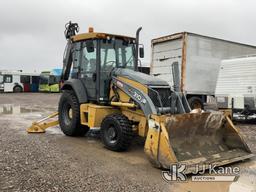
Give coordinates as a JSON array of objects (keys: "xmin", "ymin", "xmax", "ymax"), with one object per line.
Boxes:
[{"xmin": 0, "ymin": 0, "xmax": 256, "ymax": 71}]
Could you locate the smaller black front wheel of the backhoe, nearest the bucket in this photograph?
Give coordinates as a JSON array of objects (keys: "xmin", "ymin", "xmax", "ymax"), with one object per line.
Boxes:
[{"xmin": 101, "ymin": 114, "xmax": 133, "ymax": 151}]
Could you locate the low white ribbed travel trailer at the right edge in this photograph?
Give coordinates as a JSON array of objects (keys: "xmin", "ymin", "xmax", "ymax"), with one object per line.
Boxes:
[{"xmin": 215, "ymin": 56, "xmax": 256, "ymax": 116}]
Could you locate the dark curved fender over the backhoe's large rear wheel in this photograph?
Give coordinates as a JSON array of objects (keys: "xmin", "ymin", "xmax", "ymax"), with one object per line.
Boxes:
[{"xmin": 61, "ymin": 79, "xmax": 88, "ymax": 104}]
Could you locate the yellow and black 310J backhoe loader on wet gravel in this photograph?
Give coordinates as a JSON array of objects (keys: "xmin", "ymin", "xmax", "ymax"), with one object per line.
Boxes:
[{"xmin": 28, "ymin": 23, "xmax": 253, "ymax": 173}]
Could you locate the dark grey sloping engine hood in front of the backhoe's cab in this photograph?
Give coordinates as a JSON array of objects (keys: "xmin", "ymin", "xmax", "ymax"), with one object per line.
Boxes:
[{"xmin": 113, "ymin": 68, "xmax": 169, "ymax": 86}]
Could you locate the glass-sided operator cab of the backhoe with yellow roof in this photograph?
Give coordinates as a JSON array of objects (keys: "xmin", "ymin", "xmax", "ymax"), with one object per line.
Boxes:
[{"xmin": 68, "ymin": 28, "xmax": 144, "ymax": 103}]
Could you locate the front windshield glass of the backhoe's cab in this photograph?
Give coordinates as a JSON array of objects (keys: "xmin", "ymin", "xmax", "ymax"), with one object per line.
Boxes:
[{"xmin": 100, "ymin": 39, "xmax": 135, "ymax": 71}]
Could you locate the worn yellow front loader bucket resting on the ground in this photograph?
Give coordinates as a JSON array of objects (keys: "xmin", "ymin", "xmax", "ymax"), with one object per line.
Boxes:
[{"xmin": 144, "ymin": 112, "xmax": 254, "ymax": 173}]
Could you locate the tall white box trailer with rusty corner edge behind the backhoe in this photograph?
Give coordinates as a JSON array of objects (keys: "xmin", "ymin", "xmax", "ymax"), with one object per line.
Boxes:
[{"xmin": 150, "ymin": 32, "xmax": 256, "ymax": 109}]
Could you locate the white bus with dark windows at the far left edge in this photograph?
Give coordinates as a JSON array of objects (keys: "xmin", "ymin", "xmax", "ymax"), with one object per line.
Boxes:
[{"xmin": 0, "ymin": 71, "xmax": 39, "ymax": 92}]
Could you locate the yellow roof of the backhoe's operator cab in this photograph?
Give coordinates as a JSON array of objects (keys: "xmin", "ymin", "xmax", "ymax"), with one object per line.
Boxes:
[{"xmin": 71, "ymin": 32, "xmax": 135, "ymax": 42}]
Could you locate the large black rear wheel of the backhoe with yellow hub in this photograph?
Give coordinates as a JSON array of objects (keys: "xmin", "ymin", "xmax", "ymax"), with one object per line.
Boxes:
[{"xmin": 58, "ymin": 90, "xmax": 89, "ymax": 136}]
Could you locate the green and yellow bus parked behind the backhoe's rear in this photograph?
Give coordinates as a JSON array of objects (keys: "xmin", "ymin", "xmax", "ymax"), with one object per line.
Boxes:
[{"xmin": 39, "ymin": 69, "xmax": 62, "ymax": 93}]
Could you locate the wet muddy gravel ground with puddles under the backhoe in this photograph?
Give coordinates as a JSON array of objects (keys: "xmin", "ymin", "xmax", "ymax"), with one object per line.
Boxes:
[{"xmin": 0, "ymin": 93, "xmax": 256, "ymax": 192}]
